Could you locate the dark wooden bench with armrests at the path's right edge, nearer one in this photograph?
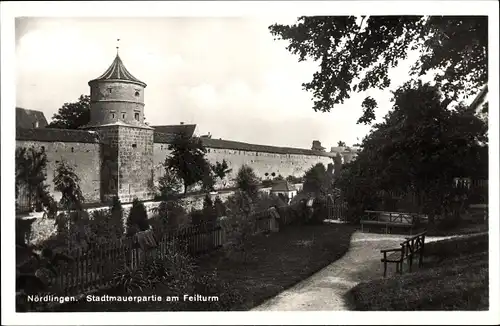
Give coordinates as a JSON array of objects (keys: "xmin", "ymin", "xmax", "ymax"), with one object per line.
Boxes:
[{"xmin": 380, "ymin": 231, "xmax": 427, "ymax": 277}]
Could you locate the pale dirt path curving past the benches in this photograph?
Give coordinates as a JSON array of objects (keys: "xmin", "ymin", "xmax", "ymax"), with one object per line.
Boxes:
[{"xmin": 252, "ymin": 232, "xmax": 450, "ymax": 311}]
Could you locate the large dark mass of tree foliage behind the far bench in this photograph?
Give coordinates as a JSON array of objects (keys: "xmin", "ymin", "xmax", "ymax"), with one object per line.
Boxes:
[{"xmin": 336, "ymin": 82, "xmax": 488, "ymax": 222}]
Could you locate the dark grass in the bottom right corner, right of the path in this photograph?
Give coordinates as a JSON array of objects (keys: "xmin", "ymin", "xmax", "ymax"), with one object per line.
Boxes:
[{"xmin": 347, "ymin": 234, "xmax": 489, "ymax": 311}]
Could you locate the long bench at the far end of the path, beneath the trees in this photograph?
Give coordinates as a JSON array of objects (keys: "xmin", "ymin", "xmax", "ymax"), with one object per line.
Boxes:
[{"xmin": 360, "ymin": 211, "xmax": 420, "ymax": 234}]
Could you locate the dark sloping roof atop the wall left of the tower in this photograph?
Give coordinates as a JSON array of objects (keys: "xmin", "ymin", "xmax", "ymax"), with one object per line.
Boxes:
[{"xmin": 16, "ymin": 128, "xmax": 99, "ymax": 143}]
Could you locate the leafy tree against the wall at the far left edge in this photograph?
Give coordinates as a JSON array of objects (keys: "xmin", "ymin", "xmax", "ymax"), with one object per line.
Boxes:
[{"xmin": 15, "ymin": 147, "xmax": 57, "ymax": 218}]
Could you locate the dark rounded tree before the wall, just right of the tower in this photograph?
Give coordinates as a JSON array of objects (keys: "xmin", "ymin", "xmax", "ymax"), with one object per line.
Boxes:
[{"xmin": 164, "ymin": 134, "xmax": 210, "ymax": 194}]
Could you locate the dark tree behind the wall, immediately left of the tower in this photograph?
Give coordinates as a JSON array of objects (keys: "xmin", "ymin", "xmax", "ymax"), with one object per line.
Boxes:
[{"xmin": 47, "ymin": 95, "xmax": 90, "ymax": 129}]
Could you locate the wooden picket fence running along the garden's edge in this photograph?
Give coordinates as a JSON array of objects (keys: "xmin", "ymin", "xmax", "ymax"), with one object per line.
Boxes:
[{"xmin": 40, "ymin": 206, "xmax": 298, "ymax": 296}]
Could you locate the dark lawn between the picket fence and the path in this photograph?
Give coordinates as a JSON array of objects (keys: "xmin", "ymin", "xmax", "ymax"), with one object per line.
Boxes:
[{"xmin": 51, "ymin": 224, "xmax": 355, "ymax": 312}]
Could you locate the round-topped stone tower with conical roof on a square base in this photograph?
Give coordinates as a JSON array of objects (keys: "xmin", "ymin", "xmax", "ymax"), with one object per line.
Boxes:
[{"xmin": 86, "ymin": 53, "xmax": 154, "ymax": 203}]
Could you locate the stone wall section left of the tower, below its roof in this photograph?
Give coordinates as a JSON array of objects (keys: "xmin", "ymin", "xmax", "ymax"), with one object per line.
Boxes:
[{"xmin": 16, "ymin": 140, "xmax": 101, "ymax": 203}]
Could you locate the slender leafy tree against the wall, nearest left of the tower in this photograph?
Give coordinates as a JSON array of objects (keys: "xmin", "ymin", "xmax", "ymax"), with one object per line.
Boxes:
[{"xmin": 54, "ymin": 160, "xmax": 85, "ymax": 211}]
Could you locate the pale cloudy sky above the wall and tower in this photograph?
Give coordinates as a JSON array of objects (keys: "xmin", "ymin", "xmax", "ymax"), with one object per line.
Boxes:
[{"xmin": 16, "ymin": 17, "xmax": 438, "ymax": 149}]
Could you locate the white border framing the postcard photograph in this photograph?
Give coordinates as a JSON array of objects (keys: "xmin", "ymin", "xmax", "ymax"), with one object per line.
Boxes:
[{"xmin": 1, "ymin": 1, "xmax": 500, "ymax": 325}]
